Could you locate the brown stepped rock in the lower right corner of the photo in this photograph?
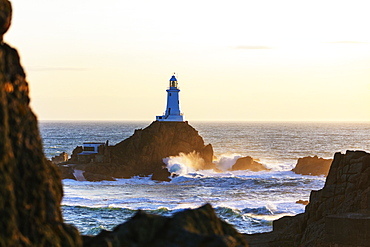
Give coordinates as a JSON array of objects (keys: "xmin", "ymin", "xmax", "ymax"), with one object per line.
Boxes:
[{"xmin": 247, "ymin": 151, "xmax": 370, "ymax": 247}]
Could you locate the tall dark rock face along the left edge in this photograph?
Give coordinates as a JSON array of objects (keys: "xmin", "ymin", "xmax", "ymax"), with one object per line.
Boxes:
[{"xmin": 0, "ymin": 0, "xmax": 81, "ymax": 246}]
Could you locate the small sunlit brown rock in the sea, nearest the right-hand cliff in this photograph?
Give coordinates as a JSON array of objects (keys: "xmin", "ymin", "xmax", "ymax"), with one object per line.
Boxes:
[{"xmin": 292, "ymin": 155, "xmax": 333, "ymax": 176}]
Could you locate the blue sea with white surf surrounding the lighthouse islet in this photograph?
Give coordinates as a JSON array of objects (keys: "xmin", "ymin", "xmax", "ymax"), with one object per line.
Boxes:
[{"xmin": 39, "ymin": 121, "xmax": 370, "ymax": 235}]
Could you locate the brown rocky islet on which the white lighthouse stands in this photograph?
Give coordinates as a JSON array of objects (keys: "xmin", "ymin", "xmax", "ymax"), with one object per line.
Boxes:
[{"xmin": 62, "ymin": 121, "xmax": 215, "ymax": 181}]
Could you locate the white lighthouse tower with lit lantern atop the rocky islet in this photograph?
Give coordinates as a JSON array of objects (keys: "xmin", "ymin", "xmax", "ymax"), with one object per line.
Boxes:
[{"xmin": 156, "ymin": 75, "xmax": 184, "ymax": 122}]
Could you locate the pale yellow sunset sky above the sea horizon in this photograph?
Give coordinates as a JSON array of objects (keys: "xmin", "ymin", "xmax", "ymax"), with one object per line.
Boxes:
[{"xmin": 4, "ymin": 0, "xmax": 370, "ymax": 121}]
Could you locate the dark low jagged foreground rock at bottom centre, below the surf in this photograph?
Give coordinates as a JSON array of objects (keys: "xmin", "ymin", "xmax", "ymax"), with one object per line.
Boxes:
[{"xmin": 84, "ymin": 204, "xmax": 248, "ymax": 247}]
